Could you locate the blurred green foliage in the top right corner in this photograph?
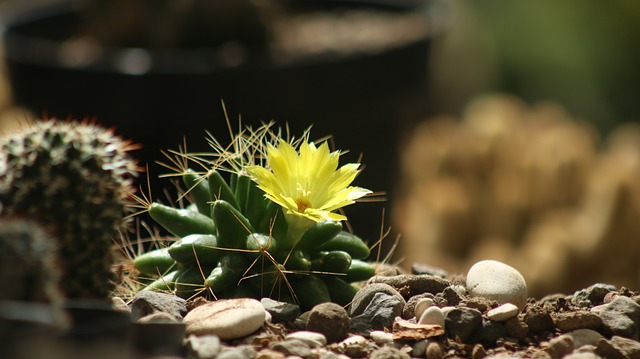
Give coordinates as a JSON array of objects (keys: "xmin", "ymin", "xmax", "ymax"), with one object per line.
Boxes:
[{"xmin": 432, "ymin": 0, "xmax": 640, "ymax": 131}]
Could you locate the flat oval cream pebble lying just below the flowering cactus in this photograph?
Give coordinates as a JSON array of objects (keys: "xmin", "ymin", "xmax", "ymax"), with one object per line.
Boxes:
[{"xmin": 184, "ymin": 298, "xmax": 266, "ymax": 340}]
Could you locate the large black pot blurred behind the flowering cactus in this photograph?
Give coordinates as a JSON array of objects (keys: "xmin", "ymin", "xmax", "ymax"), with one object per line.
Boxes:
[{"xmin": 0, "ymin": 0, "xmax": 440, "ymax": 245}]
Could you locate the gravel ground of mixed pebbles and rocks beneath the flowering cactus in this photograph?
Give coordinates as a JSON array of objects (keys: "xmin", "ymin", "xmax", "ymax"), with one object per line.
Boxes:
[{"xmin": 12, "ymin": 261, "xmax": 640, "ymax": 359}]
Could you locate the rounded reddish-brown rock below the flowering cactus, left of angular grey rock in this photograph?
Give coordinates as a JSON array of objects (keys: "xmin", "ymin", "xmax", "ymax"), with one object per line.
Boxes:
[{"xmin": 307, "ymin": 302, "xmax": 348, "ymax": 343}]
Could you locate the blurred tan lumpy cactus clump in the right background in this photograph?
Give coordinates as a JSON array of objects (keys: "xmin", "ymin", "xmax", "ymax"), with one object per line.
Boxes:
[{"xmin": 395, "ymin": 96, "xmax": 640, "ymax": 295}]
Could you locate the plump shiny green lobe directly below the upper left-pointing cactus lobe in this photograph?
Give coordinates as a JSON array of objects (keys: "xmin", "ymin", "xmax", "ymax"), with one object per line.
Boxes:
[{"xmin": 168, "ymin": 234, "xmax": 228, "ymax": 266}]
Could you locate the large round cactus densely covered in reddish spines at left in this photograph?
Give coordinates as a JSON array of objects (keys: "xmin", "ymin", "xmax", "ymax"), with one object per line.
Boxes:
[{"xmin": 0, "ymin": 119, "xmax": 137, "ymax": 299}]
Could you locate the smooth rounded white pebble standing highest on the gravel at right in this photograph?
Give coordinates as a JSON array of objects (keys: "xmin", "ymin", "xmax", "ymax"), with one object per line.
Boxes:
[{"xmin": 466, "ymin": 260, "xmax": 528, "ymax": 310}]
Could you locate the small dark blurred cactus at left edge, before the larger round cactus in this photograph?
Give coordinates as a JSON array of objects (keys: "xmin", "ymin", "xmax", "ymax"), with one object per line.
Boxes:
[{"xmin": 0, "ymin": 218, "xmax": 62, "ymax": 305}]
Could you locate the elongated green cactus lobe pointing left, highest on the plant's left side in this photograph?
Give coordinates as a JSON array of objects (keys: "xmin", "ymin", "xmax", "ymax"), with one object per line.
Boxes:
[{"xmin": 149, "ymin": 203, "xmax": 216, "ymax": 237}]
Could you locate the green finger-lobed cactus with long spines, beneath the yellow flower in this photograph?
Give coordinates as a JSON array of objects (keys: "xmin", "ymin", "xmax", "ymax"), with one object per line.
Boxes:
[{"xmin": 134, "ymin": 125, "xmax": 375, "ymax": 309}]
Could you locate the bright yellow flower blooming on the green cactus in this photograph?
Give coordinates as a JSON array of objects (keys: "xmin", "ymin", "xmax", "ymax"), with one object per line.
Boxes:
[{"xmin": 247, "ymin": 140, "xmax": 371, "ymax": 222}]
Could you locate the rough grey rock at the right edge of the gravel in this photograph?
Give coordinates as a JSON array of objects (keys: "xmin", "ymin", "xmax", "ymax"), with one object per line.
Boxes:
[{"xmin": 591, "ymin": 296, "xmax": 640, "ymax": 339}]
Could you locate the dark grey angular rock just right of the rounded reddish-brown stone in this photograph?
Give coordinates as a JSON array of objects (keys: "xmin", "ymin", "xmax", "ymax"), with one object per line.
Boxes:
[{"xmin": 351, "ymin": 293, "xmax": 405, "ymax": 335}]
